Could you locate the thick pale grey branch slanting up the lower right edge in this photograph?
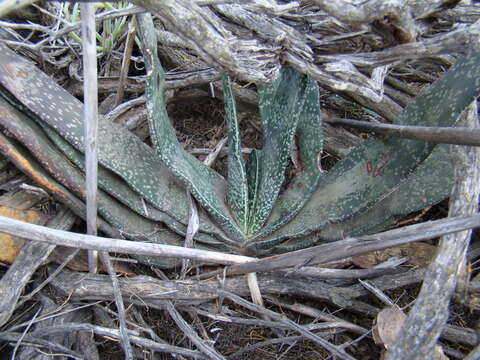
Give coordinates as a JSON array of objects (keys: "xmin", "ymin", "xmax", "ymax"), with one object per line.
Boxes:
[{"xmin": 387, "ymin": 102, "xmax": 480, "ymax": 360}]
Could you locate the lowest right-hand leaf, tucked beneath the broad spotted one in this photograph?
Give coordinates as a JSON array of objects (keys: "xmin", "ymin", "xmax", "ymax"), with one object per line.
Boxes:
[{"xmin": 250, "ymin": 145, "xmax": 453, "ymax": 255}]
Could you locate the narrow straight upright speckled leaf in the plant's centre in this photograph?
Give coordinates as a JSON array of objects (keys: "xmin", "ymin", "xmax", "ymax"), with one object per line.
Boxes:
[{"xmin": 223, "ymin": 76, "xmax": 248, "ymax": 232}]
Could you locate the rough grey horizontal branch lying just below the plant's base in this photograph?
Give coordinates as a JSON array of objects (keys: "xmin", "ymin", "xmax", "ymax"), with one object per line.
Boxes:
[{"xmin": 47, "ymin": 269, "xmax": 424, "ymax": 321}]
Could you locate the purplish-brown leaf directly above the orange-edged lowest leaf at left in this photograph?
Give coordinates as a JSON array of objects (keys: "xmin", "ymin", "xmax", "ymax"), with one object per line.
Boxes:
[{"xmin": 0, "ymin": 97, "xmax": 227, "ymax": 249}]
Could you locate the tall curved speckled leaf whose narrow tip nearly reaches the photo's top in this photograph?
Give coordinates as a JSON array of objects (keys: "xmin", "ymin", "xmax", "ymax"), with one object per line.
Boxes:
[{"xmin": 138, "ymin": 13, "xmax": 244, "ymax": 240}]
